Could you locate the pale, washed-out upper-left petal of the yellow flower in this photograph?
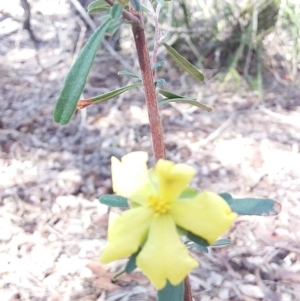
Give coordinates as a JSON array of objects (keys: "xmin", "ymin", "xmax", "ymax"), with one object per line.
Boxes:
[{"xmin": 111, "ymin": 152, "xmax": 149, "ymax": 198}]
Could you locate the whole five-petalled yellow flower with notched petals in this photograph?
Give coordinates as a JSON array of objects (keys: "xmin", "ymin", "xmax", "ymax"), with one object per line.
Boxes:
[{"xmin": 100, "ymin": 152, "xmax": 236, "ymax": 290}]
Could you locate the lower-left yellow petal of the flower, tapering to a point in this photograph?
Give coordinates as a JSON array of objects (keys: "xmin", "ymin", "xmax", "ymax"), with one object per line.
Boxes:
[{"xmin": 100, "ymin": 207, "xmax": 153, "ymax": 263}]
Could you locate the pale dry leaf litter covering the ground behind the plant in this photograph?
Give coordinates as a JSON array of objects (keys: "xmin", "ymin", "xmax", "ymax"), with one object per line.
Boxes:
[{"xmin": 0, "ymin": 0, "xmax": 300, "ymax": 301}]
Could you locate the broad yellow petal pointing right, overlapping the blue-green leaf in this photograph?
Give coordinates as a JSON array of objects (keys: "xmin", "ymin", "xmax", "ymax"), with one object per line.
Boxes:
[{"xmin": 170, "ymin": 191, "xmax": 237, "ymax": 244}]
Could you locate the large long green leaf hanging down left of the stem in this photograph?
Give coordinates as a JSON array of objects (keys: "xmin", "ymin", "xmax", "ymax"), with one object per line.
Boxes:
[{"xmin": 54, "ymin": 20, "xmax": 111, "ymax": 124}]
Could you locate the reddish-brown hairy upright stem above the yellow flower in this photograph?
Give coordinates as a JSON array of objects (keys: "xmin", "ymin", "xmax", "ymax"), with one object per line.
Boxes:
[{"xmin": 130, "ymin": 7, "xmax": 166, "ymax": 161}]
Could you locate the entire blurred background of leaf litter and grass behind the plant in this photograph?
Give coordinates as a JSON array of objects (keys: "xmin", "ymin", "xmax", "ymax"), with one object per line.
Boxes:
[{"xmin": 0, "ymin": 0, "xmax": 300, "ymax": 301}]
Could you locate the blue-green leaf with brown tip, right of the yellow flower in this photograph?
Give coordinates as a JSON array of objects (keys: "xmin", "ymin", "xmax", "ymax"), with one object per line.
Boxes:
[{"xmin": 219, "ymin": 193, "xmax": 281, "ymax": 216}]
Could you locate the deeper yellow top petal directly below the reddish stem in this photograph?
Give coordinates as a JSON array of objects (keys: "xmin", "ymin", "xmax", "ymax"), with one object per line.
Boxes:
[{"xmin": 155, "ymin": 159, "xmax": 196, "ymax": 201}]
